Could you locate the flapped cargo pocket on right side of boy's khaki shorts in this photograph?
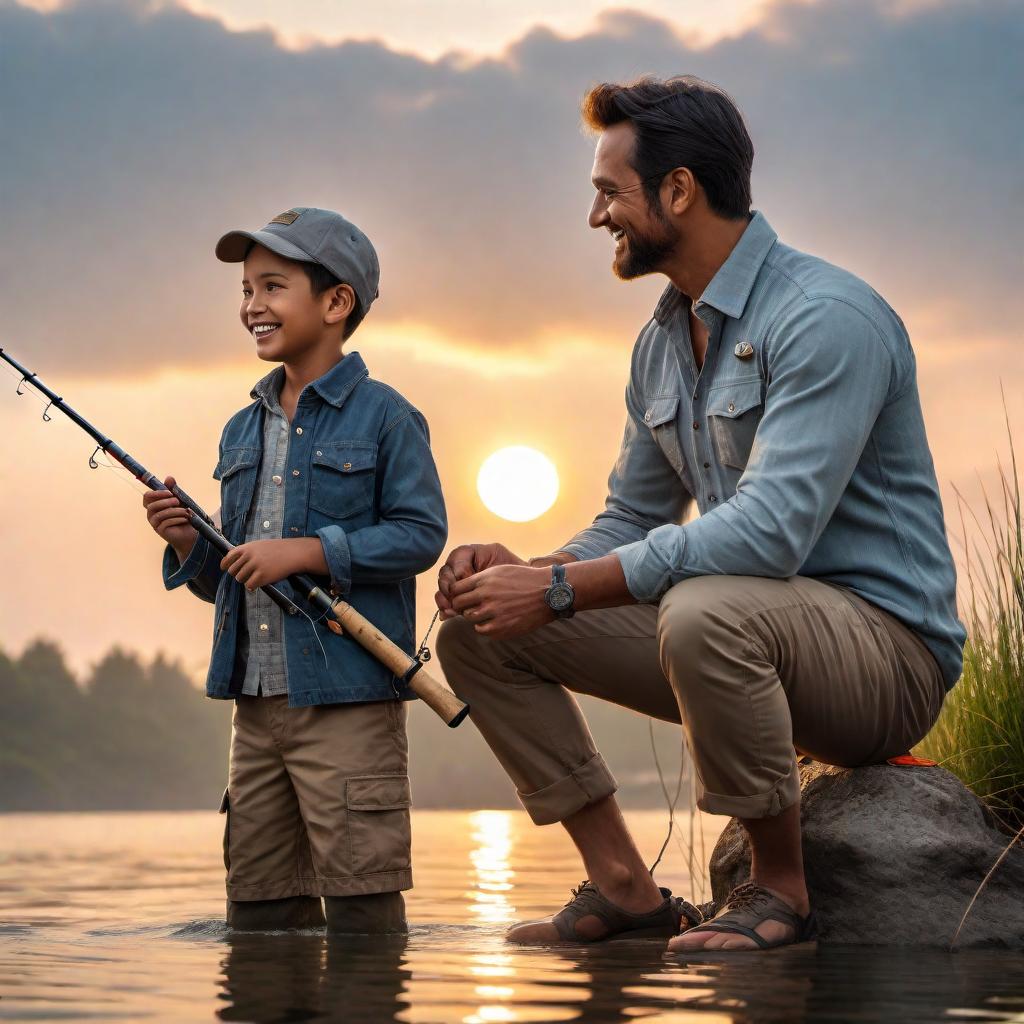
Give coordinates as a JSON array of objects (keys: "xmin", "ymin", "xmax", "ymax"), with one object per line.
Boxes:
[{"xmin": 345, "ymin": 775, "xmax": 413, "ymax": 874}]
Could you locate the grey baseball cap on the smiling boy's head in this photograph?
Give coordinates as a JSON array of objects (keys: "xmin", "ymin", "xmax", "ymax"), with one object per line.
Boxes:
[{"xmin": 216, "ymin": 206, "xmax": 381, "ymax": 312}]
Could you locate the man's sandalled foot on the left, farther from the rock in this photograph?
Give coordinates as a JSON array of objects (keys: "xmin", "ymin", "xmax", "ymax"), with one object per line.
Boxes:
[{"xmin": 505, "ymin": 881, "xmax": 681, "ymax": 945}]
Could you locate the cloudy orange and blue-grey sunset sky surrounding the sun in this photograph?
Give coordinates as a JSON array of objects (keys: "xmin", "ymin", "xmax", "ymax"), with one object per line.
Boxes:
[{"xmin": 0, "ymin": 0, "xmax": 1024, "ymax": 676}]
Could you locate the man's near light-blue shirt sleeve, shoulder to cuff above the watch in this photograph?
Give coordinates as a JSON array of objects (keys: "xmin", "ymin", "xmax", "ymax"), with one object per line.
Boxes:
[{"xmin": 615, "ymin": 298, "xmax": 894, "ymax": 602}]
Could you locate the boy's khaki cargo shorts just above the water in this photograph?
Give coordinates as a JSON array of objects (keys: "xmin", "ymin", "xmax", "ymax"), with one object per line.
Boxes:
[{"xmin": 221, "ymin": 696, "xmax": 413, "ymax": 900}]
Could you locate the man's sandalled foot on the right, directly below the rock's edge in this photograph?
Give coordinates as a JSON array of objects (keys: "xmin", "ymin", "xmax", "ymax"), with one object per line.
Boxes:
[{"xmin": 669, "ymin": 882, "xmax": 816, "ymax": 953}]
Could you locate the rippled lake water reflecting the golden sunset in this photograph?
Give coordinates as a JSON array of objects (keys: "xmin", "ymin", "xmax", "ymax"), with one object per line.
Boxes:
[{"xmin": 0, "ymin": 811, "xmax": 1024, "ymax": 1024}]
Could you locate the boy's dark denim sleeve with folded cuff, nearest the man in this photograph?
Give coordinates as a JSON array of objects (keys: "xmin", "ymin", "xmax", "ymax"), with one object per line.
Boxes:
[{"xmin": 316, "ymin": 409, "xmax": 447, "ymax": 596}]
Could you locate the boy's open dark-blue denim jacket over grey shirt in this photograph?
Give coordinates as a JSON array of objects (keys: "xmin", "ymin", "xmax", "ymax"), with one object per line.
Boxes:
[{"xmin": 163, "ymin": 352, "xmax": 447, "ymax": 707}]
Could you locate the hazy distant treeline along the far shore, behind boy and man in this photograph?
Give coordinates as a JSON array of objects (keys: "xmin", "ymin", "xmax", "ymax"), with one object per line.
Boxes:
[{"xmin": 0, "ymin": 640, "xmax": 685, "ymax": 812}]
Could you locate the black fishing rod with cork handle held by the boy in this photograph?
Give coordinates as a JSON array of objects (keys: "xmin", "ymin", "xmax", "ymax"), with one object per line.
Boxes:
[{"xmin": 0, "ymin": 348, "xmax": 469, "ymax": 729}]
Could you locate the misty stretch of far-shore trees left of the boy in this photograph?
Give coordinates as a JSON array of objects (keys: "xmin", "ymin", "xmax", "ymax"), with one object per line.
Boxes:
[{"xmin": 0, "ymin": 640, "xmax": 230, "ymax": 811}]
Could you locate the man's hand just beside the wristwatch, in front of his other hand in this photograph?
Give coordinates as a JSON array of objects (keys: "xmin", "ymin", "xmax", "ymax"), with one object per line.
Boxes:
[{"xmin": 449, "ymin": 564, "xmax": 555, "ymax": 640}]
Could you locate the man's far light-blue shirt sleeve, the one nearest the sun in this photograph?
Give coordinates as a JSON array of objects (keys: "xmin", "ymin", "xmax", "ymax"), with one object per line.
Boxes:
[{"xmin": 558, "ymin": 368, "xmax": 692, "ymax": 561}]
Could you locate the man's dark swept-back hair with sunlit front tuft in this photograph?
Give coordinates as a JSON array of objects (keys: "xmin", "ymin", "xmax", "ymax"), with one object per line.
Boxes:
[{"xmin": 583, "ymin": 75, "xmax": 754, "ymax": 220}]
